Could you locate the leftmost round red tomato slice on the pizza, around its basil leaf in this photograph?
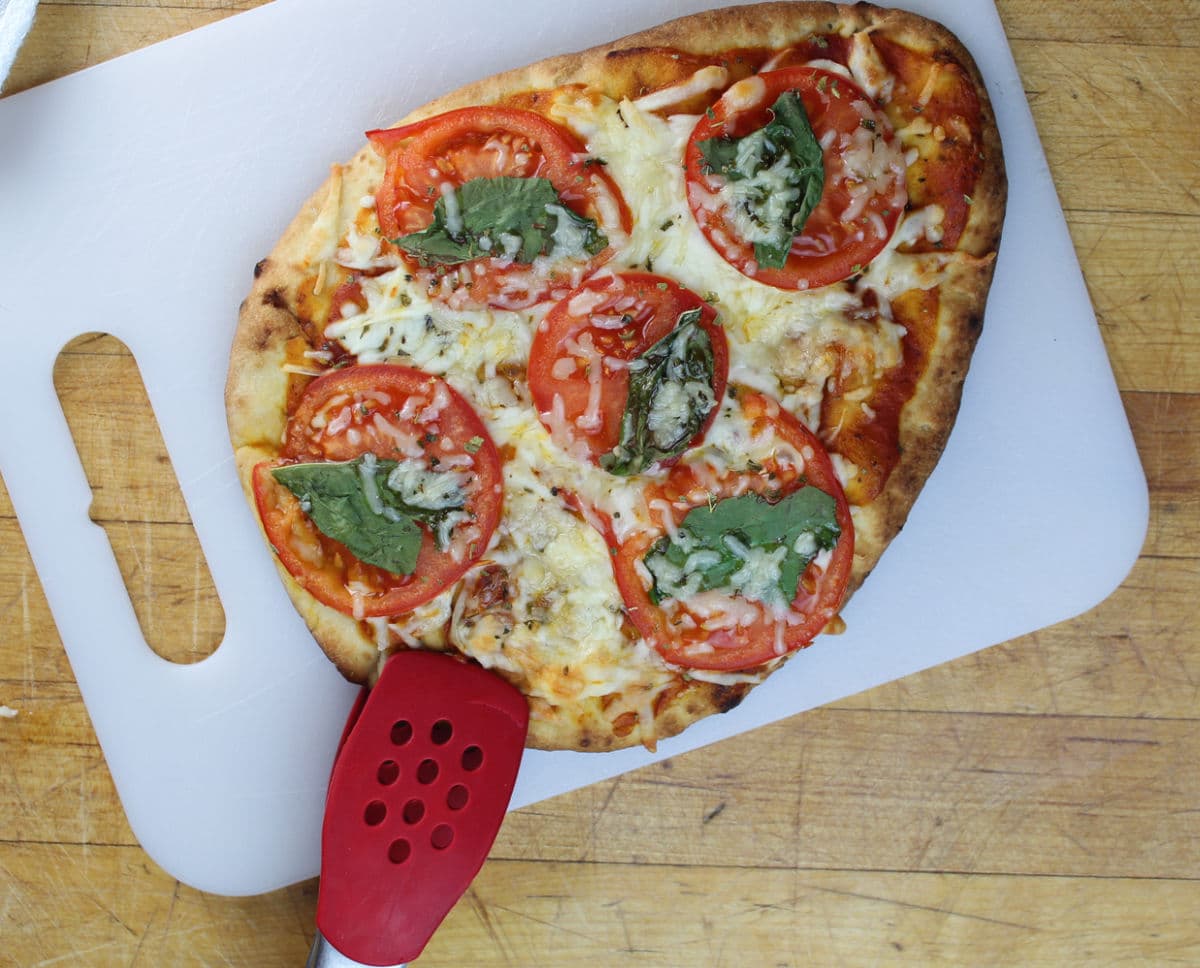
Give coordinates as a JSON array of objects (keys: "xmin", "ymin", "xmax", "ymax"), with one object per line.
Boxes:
[{"xmin": 253, "ymin": 363, "xmax": 502, "ymax": 618}]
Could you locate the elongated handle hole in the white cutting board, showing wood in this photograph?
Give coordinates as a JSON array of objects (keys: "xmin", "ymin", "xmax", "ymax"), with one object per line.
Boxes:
[{"xmin": 54, "ymin": 332, "xmax": 224, "ymax": 663}]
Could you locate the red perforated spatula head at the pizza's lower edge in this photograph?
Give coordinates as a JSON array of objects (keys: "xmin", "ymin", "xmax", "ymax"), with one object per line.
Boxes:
[{"xmin": 308, "ymin": 651, "xmax": 529, "ymax": 968}]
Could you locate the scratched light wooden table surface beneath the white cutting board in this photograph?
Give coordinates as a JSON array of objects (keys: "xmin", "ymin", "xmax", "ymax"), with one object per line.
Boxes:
[{"xmin": 0, "ymin": 0, "xmax": 1200, "ymax": 968}]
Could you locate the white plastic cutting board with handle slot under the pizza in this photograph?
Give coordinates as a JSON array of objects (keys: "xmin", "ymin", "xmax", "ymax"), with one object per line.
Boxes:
[{"xmin": 0, "ymin": 0, "xmax": 1147, "ymax": 894}]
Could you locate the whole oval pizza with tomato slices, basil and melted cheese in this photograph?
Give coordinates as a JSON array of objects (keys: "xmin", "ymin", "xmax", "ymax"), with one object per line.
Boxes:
[{"xmin": 226, "ymin": 2, "xmax": 1006, "ymax": 751}]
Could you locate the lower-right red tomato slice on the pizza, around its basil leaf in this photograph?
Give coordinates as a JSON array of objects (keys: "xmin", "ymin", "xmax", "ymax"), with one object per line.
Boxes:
[{"xmin": 601, "ymin": 389, "xmax": 854, "ymax": 672}]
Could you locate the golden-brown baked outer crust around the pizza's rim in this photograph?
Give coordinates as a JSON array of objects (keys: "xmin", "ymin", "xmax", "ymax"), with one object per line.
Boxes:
[{"xmin": 226, "ymin": 2, "xmax": 1006, "ymax": 751}]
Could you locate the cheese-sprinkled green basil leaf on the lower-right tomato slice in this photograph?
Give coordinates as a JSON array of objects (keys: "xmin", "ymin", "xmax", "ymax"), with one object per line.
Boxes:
[{"xmin": 644, "ymin": 487, "xmax": 841, "ymax": 606}]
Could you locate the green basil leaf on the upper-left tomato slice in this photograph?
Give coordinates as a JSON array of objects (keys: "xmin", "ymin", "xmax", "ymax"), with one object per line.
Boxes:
[{"xmin": 391, "ymin": 175, "xmax": 608, "ymax": 265}]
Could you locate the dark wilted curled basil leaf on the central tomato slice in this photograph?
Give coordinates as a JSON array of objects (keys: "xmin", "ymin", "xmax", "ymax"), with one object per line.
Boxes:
[{"xmin": 600, "ymin": 309, "xmax": 716, "ymax": 477}]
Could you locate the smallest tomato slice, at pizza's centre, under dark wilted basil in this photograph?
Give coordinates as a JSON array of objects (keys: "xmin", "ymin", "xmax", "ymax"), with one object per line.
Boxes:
[{"xmin": 529, "ymin": 272, "xmax": 730, "ymax": 463}]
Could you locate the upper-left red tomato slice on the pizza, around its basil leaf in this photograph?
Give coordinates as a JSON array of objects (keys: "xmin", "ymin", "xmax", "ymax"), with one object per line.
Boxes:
[{"xmin": 367, "ymin": 107, "xmax": 632, "ymax": 308}]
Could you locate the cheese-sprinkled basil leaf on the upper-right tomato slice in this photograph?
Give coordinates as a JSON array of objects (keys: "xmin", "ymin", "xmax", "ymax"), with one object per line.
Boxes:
[{"xmin": 697, "ymin": 91, "xmax": 824, "ymax": 269}]
